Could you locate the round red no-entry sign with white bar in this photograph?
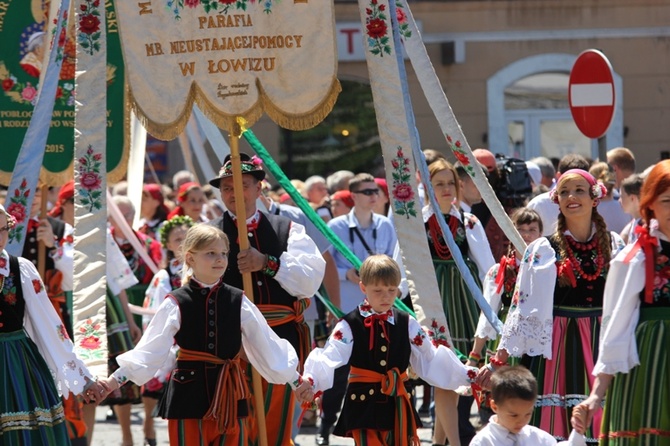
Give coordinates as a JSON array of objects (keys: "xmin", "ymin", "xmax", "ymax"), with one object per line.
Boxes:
[{"xmin": 568, "ymin": 50, "xmax": 616, "ymax": 138}]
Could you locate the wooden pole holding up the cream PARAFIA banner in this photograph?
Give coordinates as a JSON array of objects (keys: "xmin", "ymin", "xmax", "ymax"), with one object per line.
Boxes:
[{"xmin": 230, "ymin": 124, "xmax": 268, "ymax": 446}]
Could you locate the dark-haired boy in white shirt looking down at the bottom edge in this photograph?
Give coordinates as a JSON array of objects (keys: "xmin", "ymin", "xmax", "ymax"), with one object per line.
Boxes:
[{"xmin": 470, "ymin": 366, "xmax": 556, "ymax": 446}]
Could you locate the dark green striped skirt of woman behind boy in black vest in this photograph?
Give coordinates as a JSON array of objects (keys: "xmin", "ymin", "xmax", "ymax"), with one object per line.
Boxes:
[{"xmin": 433, "ymin": 259, "xmax": 481, "ymax": 356}]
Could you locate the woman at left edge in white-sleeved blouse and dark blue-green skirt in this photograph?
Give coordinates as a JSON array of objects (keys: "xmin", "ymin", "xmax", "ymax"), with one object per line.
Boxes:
[{"xmin": 0, "ymin": 205, "xmax": 105, "ymax": 445}]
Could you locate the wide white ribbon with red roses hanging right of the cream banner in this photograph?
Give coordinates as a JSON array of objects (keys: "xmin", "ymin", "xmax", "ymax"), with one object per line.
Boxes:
[{"xmin": 358, "ymin": 0, "xmax": 454, "ymax": 346}]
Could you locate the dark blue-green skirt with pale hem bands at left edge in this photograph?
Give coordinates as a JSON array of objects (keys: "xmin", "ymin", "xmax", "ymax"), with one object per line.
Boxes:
[{"xmin": 0, "ymin": 330, "xmax": 70, "ymax": 445}]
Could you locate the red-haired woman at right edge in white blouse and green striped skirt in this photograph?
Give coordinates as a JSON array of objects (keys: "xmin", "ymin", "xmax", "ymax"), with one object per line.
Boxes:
[{"xmin": 572, "ymin": 160, "xmax": 670, "ymax": 446}]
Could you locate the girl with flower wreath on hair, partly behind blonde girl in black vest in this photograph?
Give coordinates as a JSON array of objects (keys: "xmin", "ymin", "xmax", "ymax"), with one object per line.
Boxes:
[{"xmin": 142, "ymin": 215, "xmax": 194, "ymax": 446}]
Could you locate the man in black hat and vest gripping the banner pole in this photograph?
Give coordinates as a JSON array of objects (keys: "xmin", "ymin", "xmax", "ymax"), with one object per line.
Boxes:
[{"xmin": 209, "ymin": 153, "xmax": 325, "ymax": 446}]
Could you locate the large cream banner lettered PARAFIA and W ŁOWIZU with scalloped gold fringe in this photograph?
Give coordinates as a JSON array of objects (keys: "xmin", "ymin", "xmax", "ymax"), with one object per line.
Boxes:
[{"xmin": 117, "ymin": 0, "xmax": 340, "ymax": 139}]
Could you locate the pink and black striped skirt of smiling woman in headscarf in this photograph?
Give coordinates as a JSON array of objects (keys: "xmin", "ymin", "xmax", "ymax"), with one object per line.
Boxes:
[{"xmin": 521, "ymin": 307, "xmax": 602, "ymax": 444}]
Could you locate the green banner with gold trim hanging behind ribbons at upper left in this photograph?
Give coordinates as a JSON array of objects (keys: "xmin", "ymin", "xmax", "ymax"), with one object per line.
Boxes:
[{"xmin": 0, "ymin": 0, "xmax": 130, "ymax": 186}]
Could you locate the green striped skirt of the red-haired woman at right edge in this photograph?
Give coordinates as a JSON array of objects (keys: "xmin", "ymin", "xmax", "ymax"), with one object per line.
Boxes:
[{"xmin": 600, "ymin": 307, "xmax": 670, "ymax": 446}]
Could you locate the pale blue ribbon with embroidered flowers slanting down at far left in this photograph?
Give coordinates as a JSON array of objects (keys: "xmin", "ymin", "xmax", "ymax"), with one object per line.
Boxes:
[{"xmin": 0, "ymin": 0, "xmax": 70, "ymax": 256}]
